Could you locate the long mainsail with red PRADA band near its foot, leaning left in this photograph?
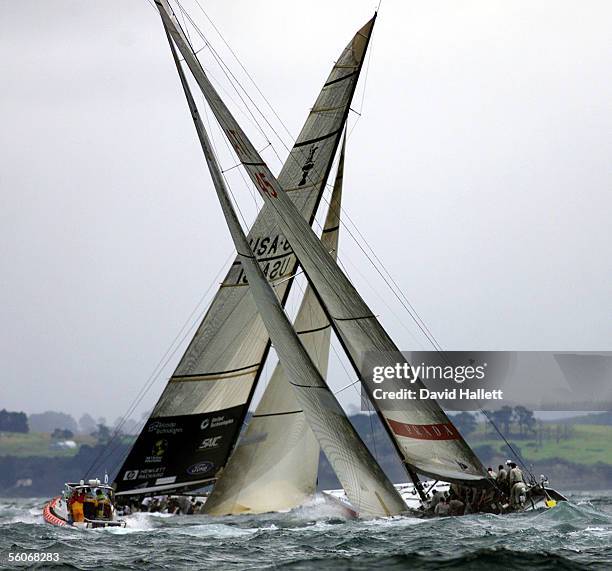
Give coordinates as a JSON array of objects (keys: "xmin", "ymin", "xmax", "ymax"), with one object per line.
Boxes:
[{"xmin": 156, "ymin": 0, "xmax": 487, "ymax": 483}]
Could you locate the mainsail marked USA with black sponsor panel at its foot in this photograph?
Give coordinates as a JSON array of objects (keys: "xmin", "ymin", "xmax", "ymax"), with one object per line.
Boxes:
[{"xmin": 115, "ymin": 5, "xmax": 371, "ymax": 494}]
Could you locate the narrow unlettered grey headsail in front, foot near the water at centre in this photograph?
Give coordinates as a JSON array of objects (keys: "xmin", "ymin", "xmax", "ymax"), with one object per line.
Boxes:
[{"xmin": 199, "ymin": 91, "xmax": 407, "ymax": 516}]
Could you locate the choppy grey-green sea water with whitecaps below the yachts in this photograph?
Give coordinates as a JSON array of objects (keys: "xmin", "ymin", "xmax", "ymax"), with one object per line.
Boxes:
[{"xmin": 0, "ymin": 492, "xmax": 612, "ymax": 571}]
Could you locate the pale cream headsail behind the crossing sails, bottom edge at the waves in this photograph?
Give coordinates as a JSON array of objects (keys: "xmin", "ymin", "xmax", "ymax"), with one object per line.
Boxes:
[{"xmin": 204, "ymin": 143, "xmax": 345, "ymax": 515}]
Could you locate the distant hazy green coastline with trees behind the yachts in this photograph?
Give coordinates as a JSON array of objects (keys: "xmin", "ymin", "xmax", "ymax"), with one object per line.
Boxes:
[{"xmin": 0, "ymin": 412, "xmax": 612, "ymax": 497}]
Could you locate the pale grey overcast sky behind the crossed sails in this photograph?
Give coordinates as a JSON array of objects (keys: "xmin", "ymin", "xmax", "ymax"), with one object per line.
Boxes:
[{"xmin": 0, "ymin": 0, "xmax": 612, "ymax": 419}]
